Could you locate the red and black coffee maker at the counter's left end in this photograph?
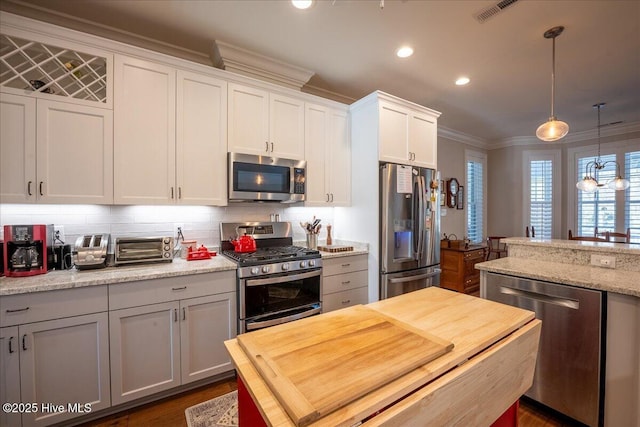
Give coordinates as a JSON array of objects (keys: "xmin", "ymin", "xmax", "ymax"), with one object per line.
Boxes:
[{"xmin": 3, "ymin": 224, "xmax": 55, "ymax": 277}]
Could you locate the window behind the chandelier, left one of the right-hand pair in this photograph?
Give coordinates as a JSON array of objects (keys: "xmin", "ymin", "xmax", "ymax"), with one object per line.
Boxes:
[{"xmin": 575, "ymin": 154, "xmax": 616, "ymax": 236}]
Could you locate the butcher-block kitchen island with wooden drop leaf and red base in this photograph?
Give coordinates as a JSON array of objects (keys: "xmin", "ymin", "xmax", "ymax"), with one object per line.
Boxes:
[{"xmin": 225, "ymin": 287, "xmax": 541, "ymax": 426}]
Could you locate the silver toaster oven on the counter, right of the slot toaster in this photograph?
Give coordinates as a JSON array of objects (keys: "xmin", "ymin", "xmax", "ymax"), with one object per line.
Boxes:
[{"xmin": 114, "ymin": 236, "xmax": 173, "ymax": 265}]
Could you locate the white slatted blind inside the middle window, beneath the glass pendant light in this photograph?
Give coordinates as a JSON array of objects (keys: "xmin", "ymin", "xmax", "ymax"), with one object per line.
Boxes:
[{"xmin": 529, "ymin": 160, "xmax": 553, "ymax": 239}]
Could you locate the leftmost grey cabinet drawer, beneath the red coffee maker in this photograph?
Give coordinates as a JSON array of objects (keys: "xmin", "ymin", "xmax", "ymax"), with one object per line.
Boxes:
[{"xmin": 0, "ymin": 286, "xmax": 108, "ymax": 327}]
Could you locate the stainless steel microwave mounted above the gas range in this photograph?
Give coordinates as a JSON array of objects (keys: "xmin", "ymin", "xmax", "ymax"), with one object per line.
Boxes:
[{"xmin": 228, "ymin": 153, "xmax": 307, "ymax": 203}]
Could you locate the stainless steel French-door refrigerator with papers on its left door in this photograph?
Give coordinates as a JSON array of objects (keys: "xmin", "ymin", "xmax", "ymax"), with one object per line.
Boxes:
[{"xmin": 380, "ymin": 163, "xmax": 440, "ymax": 299}]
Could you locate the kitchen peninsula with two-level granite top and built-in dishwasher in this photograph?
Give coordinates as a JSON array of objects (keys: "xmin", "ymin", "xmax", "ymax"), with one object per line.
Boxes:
[{"xmin": 476, "ymin": 238, "xmax": 640, "ymax": 427}]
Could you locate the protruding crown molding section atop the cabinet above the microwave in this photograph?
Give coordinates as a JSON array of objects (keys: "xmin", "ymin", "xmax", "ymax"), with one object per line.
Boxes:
[{"xmin": 211, "ymin": 40, "xmax": 315, "ymax": 90}]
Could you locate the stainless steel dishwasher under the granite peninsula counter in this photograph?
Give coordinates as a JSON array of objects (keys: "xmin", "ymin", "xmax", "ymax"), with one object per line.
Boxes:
[{"xmin": 480, "ymin": 272, "xmax": 606, "ymax": 427}]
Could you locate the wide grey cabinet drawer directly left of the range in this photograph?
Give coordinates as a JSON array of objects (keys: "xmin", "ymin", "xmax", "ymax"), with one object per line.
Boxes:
[{"xmin": 109, "ymin": 270, "xmax": 236, "ymax": 310}]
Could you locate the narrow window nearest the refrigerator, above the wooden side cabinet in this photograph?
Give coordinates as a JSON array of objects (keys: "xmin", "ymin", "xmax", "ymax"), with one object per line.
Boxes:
[{"xmin": 464, "ymin": 151, "xmax": 487, "ymax": 243}]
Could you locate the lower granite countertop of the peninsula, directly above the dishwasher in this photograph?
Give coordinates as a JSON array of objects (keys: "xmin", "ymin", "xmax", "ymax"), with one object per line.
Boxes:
[{"xmin": 476, "ymin": 256, "xmax": 640, "ymax": 297}]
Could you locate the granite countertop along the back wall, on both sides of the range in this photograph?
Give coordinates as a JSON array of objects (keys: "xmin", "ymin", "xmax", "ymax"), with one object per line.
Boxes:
[{"xmin": 0, "ymin": 243, "xmax": 369, "ymax": 296}]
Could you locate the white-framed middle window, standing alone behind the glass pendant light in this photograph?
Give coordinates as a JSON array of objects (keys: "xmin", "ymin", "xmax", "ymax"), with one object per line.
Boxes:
[{"xmin": 522, "ymin": 150, "xmax": 561, "ymax": 239}]
